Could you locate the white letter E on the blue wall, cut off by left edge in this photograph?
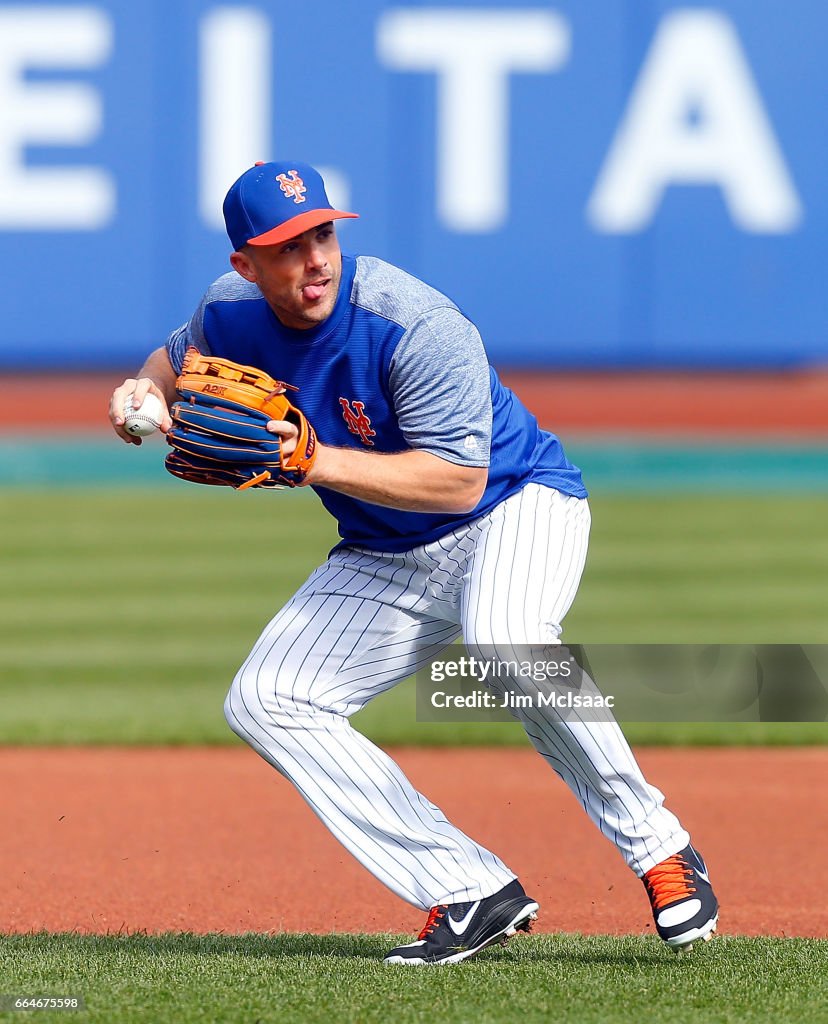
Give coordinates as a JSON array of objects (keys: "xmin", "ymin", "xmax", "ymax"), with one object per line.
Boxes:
[{"xmin": 0, "ymin": 5, "xmax": 116, "ymax": 231}]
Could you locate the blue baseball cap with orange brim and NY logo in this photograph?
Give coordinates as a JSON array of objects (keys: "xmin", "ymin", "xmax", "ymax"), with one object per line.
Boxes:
[{"xmin": 224, "ymin": 160, "xmax": 359, "ymax": 251}]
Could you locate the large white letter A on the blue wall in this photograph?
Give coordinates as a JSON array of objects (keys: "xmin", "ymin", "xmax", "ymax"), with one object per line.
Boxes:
[{"xmin": 587, "ymin": 10, "xmax": 801, "ymax": 233}]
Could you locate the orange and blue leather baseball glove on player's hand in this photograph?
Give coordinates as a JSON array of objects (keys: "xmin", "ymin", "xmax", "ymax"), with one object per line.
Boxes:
[{"xmin": 165, "ymin": 348, "xmax": 316, "ymax": 490}]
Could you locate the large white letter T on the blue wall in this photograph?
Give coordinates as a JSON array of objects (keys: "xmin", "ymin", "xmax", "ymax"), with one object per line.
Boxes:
[{"xmin": 377, "ymin": 8, "xmax": 569, "ymax": 231}]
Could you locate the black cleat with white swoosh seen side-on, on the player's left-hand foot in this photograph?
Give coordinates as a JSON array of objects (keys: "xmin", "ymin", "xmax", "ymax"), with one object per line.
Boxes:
[{"xmin": 385, "ymin": 879, "xmax": 537, "ymax": 967}]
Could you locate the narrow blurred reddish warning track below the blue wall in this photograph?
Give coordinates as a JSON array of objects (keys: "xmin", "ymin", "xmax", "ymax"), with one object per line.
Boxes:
[{"xmin": 0, "ymin": 370, "xmax": 828, "ymax": 437}]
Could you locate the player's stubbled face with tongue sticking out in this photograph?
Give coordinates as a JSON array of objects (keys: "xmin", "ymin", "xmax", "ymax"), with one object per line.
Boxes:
[{"xmin": 230, "ymin": 222, "xmax": 342, "ymax": 331}]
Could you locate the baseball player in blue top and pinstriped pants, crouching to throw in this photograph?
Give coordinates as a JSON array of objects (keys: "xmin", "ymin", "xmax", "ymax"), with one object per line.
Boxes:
[{"xmin": 110, "ymin": 161, "xmax": 718, "ymax": 966}]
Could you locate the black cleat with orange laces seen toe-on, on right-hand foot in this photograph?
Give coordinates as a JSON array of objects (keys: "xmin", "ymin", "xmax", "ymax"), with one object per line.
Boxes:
[{"xmin": 642, "ymin": 846, "xmax": 718, "ymax": 952}]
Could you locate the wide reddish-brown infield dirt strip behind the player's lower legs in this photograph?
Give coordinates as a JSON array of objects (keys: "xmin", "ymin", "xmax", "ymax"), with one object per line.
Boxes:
[{"xmin": 0, "ymin": 748, "xmax": 828, "ymax": 937}]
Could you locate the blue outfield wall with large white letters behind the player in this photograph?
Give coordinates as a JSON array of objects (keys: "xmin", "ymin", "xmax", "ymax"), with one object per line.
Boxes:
[{"xmin": 0, "ymin": 0, "xmax": 828, "ymax": 369}]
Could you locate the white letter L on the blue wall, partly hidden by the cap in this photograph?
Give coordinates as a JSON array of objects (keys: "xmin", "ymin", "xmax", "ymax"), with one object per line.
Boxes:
[{"xmin": 199, "ymin": 7, "xmax": 272, "ymax": 228}]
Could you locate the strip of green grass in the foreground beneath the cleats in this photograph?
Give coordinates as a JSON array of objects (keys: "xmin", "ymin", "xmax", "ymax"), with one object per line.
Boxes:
[{"xmin": 0, "ymin": 935, "xmax": 828, "ymax": 1024}]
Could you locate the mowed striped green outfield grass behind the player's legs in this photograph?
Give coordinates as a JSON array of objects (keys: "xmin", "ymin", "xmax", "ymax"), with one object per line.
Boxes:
[{"xmin": 0, "ymin": 484, "xmax": 828, "ymax": 743}]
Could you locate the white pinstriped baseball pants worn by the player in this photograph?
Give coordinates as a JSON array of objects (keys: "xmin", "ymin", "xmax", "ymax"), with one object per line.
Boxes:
[{"xmin": 224, "ymin": 483, "xmax": 690, "ymax": 909}]
